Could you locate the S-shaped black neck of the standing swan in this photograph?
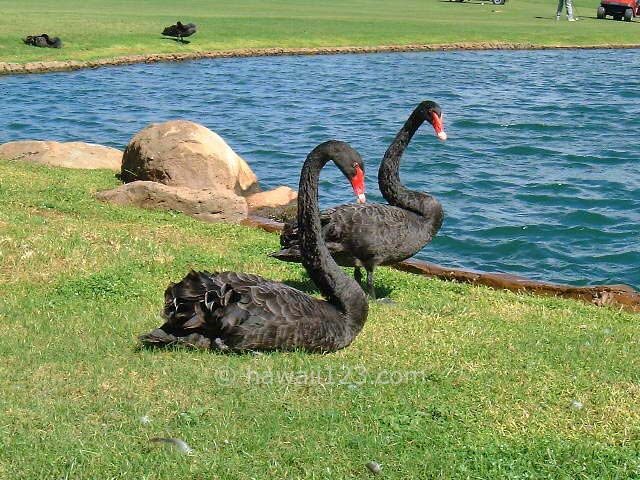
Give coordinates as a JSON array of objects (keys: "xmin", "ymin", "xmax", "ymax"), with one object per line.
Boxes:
[{"xmin": 378, "ymin": 106, "xmax": 444, "ymax": 232}]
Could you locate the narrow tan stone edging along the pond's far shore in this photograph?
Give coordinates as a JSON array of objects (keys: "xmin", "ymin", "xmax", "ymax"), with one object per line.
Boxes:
[{"xmin": 0, "ymin": 42, "xmax": 640, "ymax": 75}]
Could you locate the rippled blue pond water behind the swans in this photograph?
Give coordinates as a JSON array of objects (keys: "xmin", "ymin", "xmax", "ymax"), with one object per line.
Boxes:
[{"xmin": 0, "ymin": 50, "xmax": 640, "ymax": 288}]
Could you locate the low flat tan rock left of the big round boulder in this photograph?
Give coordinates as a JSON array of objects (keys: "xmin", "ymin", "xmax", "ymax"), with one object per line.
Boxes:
[{"xmin": 0, "ymin": 140, "xmax": 122, "ymax": 171}]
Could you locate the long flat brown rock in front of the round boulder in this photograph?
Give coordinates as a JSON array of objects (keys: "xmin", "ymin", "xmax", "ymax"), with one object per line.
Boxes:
[{"xmin": 96, "ymin": 181, "xmax": 247, "ymax": 223}]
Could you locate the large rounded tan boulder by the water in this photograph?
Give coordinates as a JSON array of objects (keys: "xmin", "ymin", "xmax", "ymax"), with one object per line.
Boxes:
[{"xmin": 121, "ymin": 120, "xmax": 260, "ymax": 195}]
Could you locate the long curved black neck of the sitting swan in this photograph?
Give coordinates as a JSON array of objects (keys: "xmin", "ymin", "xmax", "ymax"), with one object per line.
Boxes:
[{"xmin": 298, "ymin": 141, "xmax": 369, "ymax": 331}]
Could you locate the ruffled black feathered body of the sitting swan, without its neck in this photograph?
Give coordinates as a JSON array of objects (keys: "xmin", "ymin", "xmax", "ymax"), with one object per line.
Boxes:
[{"xmin": 149, "ymin": 271, "xmax": 344, "ymax": 351}]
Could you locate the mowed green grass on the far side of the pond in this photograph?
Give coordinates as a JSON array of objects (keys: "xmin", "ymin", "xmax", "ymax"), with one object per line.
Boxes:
[{"xmin": 0, "ymin": 0, "xmax": 640, "ymax": 62}]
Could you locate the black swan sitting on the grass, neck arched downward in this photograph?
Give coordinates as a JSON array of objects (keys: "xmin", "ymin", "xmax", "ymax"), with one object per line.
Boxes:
[{"xmin": 140, "ymin": 140, "xmax": 369, "ymax": 352}]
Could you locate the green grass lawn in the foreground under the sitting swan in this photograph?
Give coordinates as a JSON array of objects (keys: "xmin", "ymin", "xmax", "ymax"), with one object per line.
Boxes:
[{"xmin": 0, "ymin": 161, "xmax": 640, "ymax": 480}]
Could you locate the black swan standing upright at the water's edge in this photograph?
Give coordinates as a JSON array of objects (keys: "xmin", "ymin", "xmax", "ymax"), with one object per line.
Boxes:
[{"xmin": 270, "ymin": 101, "xmax": 447, "ymax": 299}]
